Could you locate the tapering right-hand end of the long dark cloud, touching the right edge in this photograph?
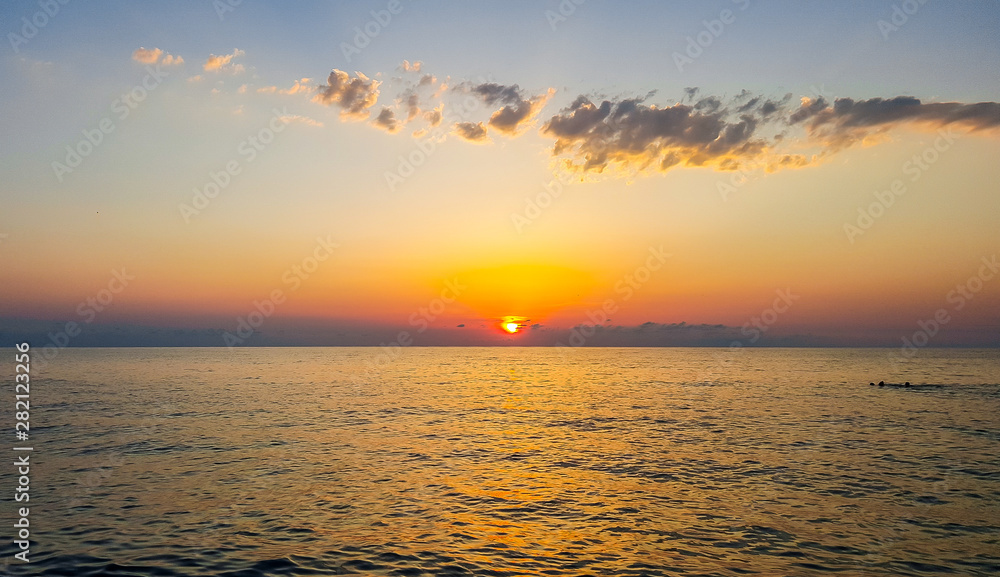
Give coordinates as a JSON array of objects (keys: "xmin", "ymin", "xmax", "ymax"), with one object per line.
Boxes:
[{"xmin": 788, "ymin": 96, "xmax": 1000, "ymax": 151}]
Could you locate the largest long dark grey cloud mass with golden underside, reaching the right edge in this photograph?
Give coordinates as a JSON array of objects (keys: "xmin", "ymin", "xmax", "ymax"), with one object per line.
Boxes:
[{"xmin": 541, "ymin": 88, "xmax": 1000, "ymax": 173}]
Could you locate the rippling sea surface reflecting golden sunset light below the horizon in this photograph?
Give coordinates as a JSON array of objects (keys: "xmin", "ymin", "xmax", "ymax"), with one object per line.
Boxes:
[{"xmin": 0, "ymin": 348, "xmax": 1000, "ymax": 577}]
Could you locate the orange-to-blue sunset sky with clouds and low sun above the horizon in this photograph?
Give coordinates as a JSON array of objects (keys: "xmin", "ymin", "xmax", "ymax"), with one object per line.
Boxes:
[{"xmin": 0, "ymin": 0, "xmax": 1000, "ymax": 351}]
